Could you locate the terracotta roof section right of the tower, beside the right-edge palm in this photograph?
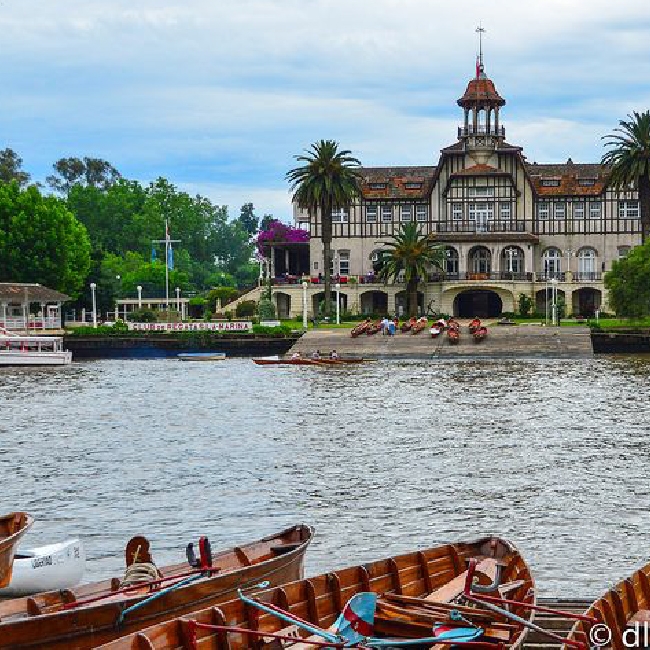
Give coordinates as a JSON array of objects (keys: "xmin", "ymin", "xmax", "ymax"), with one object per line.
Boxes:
[{"xmin": 526, "ymin": 162, "xmax": 608, "ymax": 196}]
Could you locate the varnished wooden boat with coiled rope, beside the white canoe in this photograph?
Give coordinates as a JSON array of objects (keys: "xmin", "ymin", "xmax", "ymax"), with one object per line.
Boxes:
[{"xmin": 0, "ymin": 526, "xmax": 313, "ymax": 650}]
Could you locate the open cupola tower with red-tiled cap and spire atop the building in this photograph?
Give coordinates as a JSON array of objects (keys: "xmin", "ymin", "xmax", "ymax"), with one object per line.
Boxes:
[{"xmin": 458, "ymin": 27, "xmax": 506, "ymax": 153}]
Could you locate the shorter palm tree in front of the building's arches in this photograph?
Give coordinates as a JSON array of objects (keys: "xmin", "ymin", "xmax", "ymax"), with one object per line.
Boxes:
[{"xmin": 379, "ymin": 221, "xmax": 444, "ymax": 316}]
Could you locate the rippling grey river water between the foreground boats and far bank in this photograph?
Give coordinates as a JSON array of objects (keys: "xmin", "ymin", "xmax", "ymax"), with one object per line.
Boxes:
[{"xmin": 0, "ymin": 357, "xmax": 650, "ymax": 597}]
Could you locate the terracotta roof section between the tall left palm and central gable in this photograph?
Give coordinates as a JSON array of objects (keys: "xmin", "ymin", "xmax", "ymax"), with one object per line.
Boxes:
[{"xmin": 360, "ymin": 165, "xmax": 436, "ymax": 200}]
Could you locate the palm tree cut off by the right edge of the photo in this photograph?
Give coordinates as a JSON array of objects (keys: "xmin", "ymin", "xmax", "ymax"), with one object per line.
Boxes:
[{"xmin": 602, "ymin": 111, "xmax": 650, "ymax": 243}]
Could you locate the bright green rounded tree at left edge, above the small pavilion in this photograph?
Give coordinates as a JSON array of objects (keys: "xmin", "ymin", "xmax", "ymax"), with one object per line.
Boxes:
[{"xmin": 0, "ymin": 181, "xmax": 90, "ymax": 298}]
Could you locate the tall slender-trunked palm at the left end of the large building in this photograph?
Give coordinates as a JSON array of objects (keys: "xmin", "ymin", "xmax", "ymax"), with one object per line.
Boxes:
[{"xmin": 286, "ymin": 140, "xmax": 361, "ymax": 316}]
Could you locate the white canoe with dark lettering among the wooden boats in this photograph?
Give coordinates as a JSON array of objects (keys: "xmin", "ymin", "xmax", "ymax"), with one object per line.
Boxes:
[{"xmin": 0, "ymin": 539, "xmax": 86, "ymax": 598}]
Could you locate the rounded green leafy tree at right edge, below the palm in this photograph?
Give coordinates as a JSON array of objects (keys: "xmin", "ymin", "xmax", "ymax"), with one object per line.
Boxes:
[{"xmin": 605, "ymin": 241, "xmax": 650, "ymax": 317}]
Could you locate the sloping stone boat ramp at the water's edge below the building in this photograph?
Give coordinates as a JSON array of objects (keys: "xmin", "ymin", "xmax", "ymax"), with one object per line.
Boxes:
[{"xmin": 290, "ymin": 321, "xmax": 594, "ymax": 359}]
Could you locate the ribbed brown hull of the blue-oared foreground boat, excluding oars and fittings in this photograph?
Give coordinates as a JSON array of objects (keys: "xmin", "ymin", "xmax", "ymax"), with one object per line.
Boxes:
[{"xmin": 95, "ymin": 537, "xmax": 535, "ymax": 650}]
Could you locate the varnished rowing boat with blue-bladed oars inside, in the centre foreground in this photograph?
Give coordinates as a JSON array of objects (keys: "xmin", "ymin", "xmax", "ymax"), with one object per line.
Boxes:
[{"xmin": 95, "ymin": 537, "xmax": 535, "ymax": 650}]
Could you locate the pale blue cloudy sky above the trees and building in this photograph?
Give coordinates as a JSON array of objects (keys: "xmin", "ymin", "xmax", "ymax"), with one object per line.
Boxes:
[{"xmin": 0, "ymin": 0, "xmax": 650, "ymax": 221}]
